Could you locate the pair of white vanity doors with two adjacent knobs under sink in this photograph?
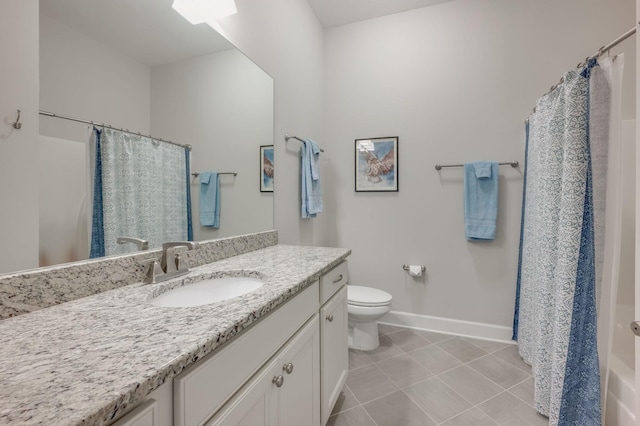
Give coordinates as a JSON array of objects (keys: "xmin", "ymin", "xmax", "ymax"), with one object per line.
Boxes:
[{"xmin": 206, "ymin": 315, "xmax": 320, "ymax": 426}]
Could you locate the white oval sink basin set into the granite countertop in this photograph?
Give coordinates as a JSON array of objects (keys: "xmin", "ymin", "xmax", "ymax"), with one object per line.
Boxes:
[{"xmin": 149, "ymin": 277, "xmax": 264, "ymax": 308}]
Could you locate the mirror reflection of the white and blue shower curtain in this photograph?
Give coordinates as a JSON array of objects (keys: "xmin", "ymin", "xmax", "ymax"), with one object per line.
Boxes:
[{"xmin": 91, "ymin": 129, "xmax": 191, "ymax": 258}]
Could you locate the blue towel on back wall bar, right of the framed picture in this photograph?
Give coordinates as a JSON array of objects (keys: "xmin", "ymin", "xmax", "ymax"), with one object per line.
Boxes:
[{"xmin": 464, "ymin": 161, "xmax": 499, "ymax": 241}]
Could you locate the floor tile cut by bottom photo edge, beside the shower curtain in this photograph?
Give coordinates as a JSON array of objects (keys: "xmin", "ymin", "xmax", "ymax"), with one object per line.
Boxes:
[{"xmin": 478, "ymin": 392, "xmax": 549, "ymax": 426}]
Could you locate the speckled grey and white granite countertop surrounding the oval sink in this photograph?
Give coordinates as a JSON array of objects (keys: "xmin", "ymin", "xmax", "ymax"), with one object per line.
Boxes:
[{"xmin": 0, "ymin": 245, "xmax": 350, "ymax": 425}]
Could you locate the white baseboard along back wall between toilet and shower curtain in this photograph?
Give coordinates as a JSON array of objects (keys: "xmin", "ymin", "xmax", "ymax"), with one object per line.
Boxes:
[{"xmin": 378, "ymin": 311, "xmax": 515, "ymax": 344}]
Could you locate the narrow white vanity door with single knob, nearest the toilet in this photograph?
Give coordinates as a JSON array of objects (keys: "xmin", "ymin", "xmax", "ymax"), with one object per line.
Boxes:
[{"xmin": 320, "ymin": 286, "xmax": 349, "ymax": 425}]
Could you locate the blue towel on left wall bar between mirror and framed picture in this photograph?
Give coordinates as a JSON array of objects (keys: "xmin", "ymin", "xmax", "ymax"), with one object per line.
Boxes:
[{"xmin": 300, "ymin": 139, "xmax": 323, "ymax": 219}]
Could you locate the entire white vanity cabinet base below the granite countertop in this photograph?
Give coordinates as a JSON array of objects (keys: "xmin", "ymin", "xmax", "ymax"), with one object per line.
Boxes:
[{"xmin": 112, "ymin": 261, "xmax": 348, "ymax": 426}]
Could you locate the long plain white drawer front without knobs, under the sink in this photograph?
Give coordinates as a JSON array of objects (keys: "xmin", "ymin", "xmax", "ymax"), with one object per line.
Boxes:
[{"xmin": 173, "ymin": 281, "xmax": 319, "ymax": 426}]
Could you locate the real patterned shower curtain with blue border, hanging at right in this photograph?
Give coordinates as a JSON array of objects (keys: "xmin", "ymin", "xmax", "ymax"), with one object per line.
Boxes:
[{"xmin": 514, "ymin": 63, "xmax": 601, "ymax": 426}]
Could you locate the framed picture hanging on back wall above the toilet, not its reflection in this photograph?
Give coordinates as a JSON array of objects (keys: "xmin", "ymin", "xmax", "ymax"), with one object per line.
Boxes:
[{"xmin": 355, "ymin": 136, "xmax": 398, "ymax": 192}]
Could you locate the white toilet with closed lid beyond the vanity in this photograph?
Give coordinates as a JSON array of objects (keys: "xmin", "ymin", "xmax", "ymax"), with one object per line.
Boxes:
[{"xmin": 347, "ymin": 285, "xmax": 391, "ymax": 351}]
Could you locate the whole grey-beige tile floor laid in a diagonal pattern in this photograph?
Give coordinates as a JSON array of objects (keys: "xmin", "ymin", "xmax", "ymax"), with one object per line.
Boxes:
[{"xmin": 327, "ymin": 324, "xmax": 548, "ymax": 426}]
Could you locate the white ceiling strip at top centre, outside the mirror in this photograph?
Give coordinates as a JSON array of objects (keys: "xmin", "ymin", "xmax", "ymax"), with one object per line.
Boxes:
[{"xmin": 307, "ymin": 0, "xmax": 452, "ymax": 27}]
